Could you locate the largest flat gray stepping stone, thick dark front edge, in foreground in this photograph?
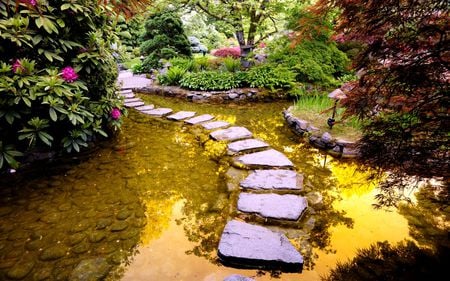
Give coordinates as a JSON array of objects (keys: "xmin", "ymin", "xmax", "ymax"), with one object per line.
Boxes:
[{"xmin": 218, "ymin": 220, "xmax": 303, "ymax": 272}]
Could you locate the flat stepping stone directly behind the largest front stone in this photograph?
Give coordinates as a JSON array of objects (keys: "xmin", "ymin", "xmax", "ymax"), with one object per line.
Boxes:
[{"xmin": 238, "ymin": 193, "xmax": 308, "ymax": 221}]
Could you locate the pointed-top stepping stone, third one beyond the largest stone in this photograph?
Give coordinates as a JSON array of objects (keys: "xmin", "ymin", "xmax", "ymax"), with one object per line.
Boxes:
[{"xmin": 234, "ymin": 149, "xmax": 294, "ymax": 168}]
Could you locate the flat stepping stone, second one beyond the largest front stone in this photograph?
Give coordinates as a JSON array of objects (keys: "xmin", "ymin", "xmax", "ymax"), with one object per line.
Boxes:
[{"xmin": 240, "ymin": 170, "xmax": 303, "ymax": 190}]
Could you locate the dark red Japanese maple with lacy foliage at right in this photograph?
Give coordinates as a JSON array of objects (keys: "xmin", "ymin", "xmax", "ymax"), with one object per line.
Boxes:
[{"xmin": 303, "ymin": 0, "xmax": 450, "ymax": 179}]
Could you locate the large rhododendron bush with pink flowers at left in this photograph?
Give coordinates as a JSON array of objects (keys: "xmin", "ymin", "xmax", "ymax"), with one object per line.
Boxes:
[{"xmin": 0, "ymin": 0, "xmax": 125, "ymax": 169}]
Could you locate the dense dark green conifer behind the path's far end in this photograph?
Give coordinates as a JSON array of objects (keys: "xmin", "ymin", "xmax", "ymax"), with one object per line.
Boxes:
[{"xmin": 141, "ymin": 12, "xmax": 191, "ymax": 72}]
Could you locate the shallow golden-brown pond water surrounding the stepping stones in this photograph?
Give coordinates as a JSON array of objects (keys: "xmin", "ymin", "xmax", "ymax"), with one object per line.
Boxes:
[{"xmin": 0, "ymin": 96, "xmax": 410, "ymax": 280}]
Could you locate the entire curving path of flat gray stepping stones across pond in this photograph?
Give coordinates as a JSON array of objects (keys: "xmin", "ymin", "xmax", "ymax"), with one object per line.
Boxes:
[{"xmin": 119, "ymin": 73, "xmax": 307, "ymax": 272}]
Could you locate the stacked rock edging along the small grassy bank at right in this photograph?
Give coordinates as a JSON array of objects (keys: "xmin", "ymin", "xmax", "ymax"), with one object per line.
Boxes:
[{"xmin": 283, "ymin": 106, "xmax": 360, "ymax": 158}]
